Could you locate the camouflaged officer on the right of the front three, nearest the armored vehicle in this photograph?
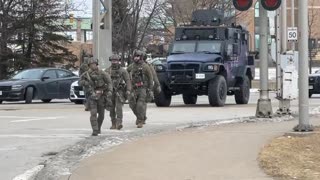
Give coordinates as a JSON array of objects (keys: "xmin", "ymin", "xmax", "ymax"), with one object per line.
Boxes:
[{"xmin": 127, "ymin": 50, "xmax": 153, "ymax": 128}]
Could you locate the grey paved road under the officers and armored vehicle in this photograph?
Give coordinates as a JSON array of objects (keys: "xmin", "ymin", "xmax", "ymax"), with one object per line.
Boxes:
[{"xmin": 0, "ymin": 93, "xmax": 320, "ymax": 180}]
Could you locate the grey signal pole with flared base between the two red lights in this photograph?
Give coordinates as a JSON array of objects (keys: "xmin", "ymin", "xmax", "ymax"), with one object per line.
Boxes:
[{"xmin": 256, "ymin": 3, "xmax": 272, "ymax": 118}]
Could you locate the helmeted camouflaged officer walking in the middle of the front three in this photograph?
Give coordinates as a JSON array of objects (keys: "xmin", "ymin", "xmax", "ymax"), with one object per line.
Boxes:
[{"xmin": 106, "ymin": 55, "xmax": 131, "ymax": 130}]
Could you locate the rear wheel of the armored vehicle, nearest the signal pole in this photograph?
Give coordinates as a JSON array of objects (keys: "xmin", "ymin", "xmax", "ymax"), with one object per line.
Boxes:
[{"xmin": 234, "ymin": 76, "xmax": 250, "ymax": 104}]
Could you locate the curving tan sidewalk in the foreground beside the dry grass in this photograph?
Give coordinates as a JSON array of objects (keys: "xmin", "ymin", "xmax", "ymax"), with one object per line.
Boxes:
[{"xmin": 62, "ymin": 117, "xmax": 320, "ymax": 180}]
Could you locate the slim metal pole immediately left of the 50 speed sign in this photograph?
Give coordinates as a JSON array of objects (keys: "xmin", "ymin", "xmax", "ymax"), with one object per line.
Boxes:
[{"xmin": 281, "ymin": 0, "xmax": 288, "ymax": 53}]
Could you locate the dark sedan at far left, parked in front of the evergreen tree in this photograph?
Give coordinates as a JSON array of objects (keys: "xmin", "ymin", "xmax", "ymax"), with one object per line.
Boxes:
[{"xmin": 0, "ymin": 68, "xmax": 79, "ymax": 104}]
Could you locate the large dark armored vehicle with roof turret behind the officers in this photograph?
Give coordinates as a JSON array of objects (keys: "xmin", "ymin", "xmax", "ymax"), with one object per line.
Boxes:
[{"xmin": 155, "ymin": 10, "xmax": 255, "ymax": 107}]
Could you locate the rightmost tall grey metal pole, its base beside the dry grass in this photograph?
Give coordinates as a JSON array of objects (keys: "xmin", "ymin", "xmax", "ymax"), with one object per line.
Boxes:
[{"xmin": 294, "ymin": 0, "xmax": 313, "ymax": 131}]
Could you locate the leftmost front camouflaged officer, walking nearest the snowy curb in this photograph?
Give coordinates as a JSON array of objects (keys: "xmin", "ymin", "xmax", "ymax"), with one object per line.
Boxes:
[{"xmin": 79, "ymin": 59, "xmax": 112, "ymax": 136}]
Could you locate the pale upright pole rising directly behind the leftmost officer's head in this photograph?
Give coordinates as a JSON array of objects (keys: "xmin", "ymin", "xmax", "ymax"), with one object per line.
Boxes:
[{"xmin": 92, "ymin": 0, "xmax": 100, "ymax": 59}]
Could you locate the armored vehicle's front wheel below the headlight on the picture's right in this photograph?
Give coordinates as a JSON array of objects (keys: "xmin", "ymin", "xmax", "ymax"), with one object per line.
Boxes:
[{"xmin": 208, "ymin": 75, "xmax": 227, "ymax": 107}]
